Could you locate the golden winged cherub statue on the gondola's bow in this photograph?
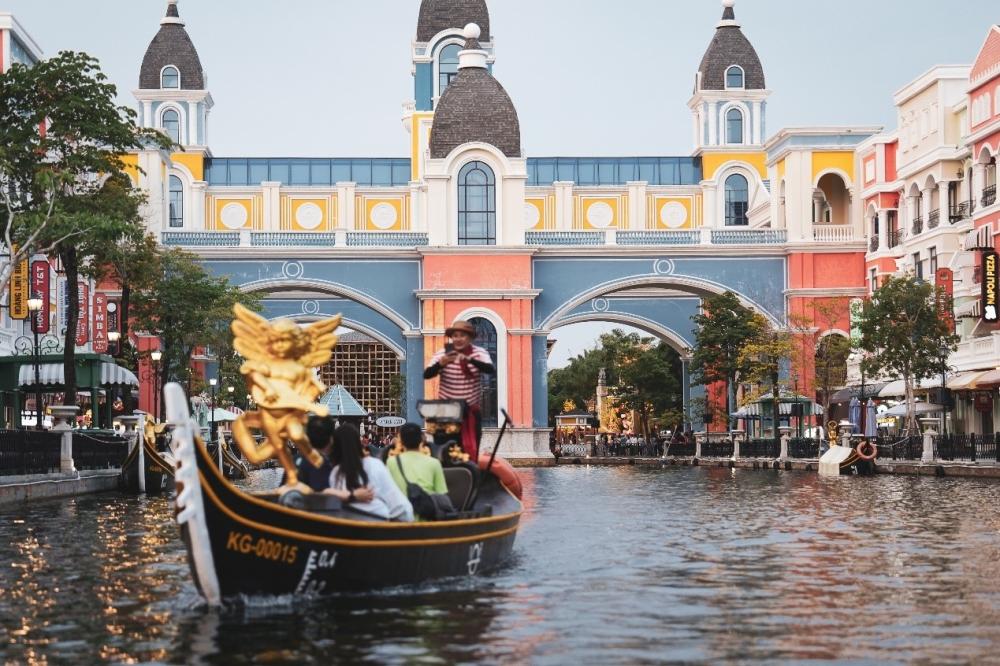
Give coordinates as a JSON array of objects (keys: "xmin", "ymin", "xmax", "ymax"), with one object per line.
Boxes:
[{"xmin": 232, "ymin": 305, "xmax": 341, "ymax": 486}]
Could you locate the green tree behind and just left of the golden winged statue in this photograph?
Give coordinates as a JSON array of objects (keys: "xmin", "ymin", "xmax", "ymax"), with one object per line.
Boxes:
[{"xmin": 132, "ymin": 248, "xmax": 260, "ymax": 410}]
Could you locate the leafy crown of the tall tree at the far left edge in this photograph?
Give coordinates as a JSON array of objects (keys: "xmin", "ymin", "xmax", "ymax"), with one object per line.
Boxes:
[{"xmin": 0, "ymin": 51, "xmax": 170, "ymax": 298}]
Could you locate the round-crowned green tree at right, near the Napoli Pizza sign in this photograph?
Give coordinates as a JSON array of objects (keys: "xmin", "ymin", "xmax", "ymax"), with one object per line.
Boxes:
[{"xmin": 858, "ymin": 275, "xmax": 959, "ymax": 434}]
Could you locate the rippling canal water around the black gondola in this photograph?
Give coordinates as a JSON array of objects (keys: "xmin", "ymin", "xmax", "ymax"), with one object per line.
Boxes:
[{"xmin": 0, "ymin": 467, "xmax": 1000, "ymax": 664}]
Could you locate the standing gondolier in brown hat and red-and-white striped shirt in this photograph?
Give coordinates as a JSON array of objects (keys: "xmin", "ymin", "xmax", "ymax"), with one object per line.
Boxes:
[{"xmin": 424, "ymin": 320, "xmax": 496, "ymax": 460}]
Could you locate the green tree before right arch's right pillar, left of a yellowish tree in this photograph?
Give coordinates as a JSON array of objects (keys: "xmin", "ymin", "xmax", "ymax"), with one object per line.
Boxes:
[{"xmin": 691, "ymin": 291, "xmax": 757, "ymax": 422}]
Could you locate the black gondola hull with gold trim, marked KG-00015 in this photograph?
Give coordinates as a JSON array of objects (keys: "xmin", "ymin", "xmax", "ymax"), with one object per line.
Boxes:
[{"xmin": 165, "ymin": 384, "xmax": 522, "ymax": 605}]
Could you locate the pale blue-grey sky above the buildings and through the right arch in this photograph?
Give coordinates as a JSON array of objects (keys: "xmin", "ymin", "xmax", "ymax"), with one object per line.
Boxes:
[{"xmin": 0, "ymin": 0, "xmax": 1000, "ymax": 367}]
